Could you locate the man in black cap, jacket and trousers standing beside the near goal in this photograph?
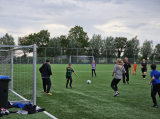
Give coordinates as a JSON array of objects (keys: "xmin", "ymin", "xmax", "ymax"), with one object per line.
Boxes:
[{"xmin": 39, "ymin": 60, "xmax": 52, "ymax": 95}]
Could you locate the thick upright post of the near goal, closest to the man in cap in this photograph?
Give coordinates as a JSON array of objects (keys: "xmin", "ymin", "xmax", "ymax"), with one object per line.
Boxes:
[{"xmin": 33, "ymin": 44, "xmax": 37, "ymax": 105}]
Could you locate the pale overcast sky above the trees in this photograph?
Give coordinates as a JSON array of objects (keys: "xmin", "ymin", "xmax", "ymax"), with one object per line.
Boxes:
[{"xmin": 0, "ymin": 0, "xmax": 160, "ymax": 45}]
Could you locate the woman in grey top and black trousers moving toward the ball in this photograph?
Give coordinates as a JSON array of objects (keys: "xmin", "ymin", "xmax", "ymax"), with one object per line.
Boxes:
[{"xmin": 111, "ymin": 59, "xmax": 126, "ymax": 97}]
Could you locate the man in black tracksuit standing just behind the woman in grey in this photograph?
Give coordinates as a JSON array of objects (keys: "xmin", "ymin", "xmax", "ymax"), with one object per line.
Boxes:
[{"xmin": 123, "ymin": 57, "xmax": 131, "ymax": 85}]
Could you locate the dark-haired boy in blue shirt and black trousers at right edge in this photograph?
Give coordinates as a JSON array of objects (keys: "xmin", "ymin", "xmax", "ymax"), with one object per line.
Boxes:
[{"xmin": 149, "ymin": 64, "xmax": 160, "ymax": 107}]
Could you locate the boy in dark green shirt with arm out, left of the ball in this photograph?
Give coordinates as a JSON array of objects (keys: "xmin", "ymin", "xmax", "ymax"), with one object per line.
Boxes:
[{"xmin": 66, "ymin": 63, "xmax": 77, "ymax": 88}]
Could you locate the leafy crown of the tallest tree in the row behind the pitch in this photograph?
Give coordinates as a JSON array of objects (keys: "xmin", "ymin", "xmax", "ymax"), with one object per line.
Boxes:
[{"xmin": 68, "ymin": 26, "xmax": 89, "ymax": 48}]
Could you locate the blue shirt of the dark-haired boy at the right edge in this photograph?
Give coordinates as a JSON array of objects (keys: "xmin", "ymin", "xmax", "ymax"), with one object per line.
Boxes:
[{"xmin": 151, "ymin": 70, "xmax": 160, "ymax": 85}]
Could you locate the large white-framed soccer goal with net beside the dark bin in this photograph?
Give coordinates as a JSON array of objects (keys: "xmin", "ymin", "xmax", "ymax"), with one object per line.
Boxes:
[{"xmin": 0, "ymin": 44, "xmax": 36, "ymax": 105}]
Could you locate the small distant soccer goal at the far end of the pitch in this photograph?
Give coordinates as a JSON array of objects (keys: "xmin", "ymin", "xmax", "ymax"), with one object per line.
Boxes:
[{"xmin": 69, "ymin": 56, "xmax": 94, "ymax": 64}]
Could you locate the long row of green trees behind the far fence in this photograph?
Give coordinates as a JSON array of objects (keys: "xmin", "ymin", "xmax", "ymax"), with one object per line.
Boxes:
[{"xmin": 0, "ymin": 26, "xmax": 160, "ymax": 60}]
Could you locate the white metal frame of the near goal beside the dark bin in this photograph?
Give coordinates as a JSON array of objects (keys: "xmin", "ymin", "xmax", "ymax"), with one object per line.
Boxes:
[{"xmin": 0, "ymin": 44, "xmax": 37, "ymax": 105}]
